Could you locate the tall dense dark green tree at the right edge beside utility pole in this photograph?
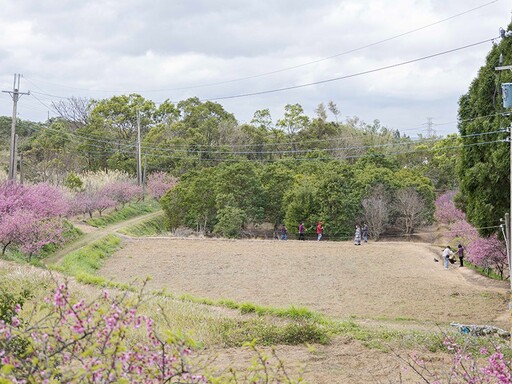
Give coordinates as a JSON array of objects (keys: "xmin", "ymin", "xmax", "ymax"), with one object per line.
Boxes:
[{"xmin": 457, "ymin": 32, "xmax": 512, "ymax": 235}]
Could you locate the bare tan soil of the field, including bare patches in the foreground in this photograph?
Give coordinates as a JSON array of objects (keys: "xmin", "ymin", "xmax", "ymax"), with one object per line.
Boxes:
[{"xmin": 100, "ymin": 238, "xmax": 510, "ymax": 383}]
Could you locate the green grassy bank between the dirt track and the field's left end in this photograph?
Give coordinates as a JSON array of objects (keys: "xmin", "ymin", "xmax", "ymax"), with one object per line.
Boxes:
[{"xmin": 55, "ymin": 235, "xmax": 121, "ymax": 278}]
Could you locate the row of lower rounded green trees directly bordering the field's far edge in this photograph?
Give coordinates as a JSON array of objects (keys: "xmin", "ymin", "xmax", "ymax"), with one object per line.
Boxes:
[{"xmin": 161, "ymin": 160, "xmax": 435, "ymax": 239}]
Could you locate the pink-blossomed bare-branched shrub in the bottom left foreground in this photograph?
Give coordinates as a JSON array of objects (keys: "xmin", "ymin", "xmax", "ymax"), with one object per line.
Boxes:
[{"xmin": 0, "ymin": 284, "xmax": 206, "ymax": 383}]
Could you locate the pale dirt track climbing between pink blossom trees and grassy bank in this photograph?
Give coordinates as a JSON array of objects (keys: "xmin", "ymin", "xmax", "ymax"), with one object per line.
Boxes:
[{"xmin": 44, "ymin": 211, "xmax": 162, "ymax": 265}]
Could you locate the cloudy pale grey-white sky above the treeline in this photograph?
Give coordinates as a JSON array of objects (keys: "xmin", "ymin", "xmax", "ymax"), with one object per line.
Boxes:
[{"xmin": 0, "ymin": 0, "xmax": 512, "ymax": 137}]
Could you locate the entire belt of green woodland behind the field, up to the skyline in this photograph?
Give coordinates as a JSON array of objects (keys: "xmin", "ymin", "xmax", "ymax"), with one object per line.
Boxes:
[{"xmin": 0, "ymin": 94, "xmax": 460, "ymax": 239}]
